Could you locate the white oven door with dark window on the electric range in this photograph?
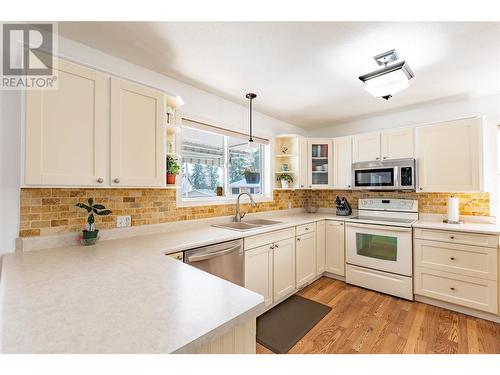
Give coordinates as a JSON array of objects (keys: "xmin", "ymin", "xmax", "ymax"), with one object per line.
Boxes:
[{"xmin": 346, "ymin": 223, "xmax": 412, "ymax": 276}]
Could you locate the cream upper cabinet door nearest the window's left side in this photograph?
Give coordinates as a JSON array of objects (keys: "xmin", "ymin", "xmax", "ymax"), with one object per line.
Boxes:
[{"xmin": 111, "ymin": 78, "xmax": 166, "ymax": 187}]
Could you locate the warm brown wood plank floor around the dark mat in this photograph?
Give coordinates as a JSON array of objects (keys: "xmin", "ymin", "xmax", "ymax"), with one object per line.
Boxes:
[{"xmin": 257, "ymin": 277, "xmax": 500, "ymax": 354}]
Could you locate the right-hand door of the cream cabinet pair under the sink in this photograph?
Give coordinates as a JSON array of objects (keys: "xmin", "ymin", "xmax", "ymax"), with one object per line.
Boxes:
[{"xmin": 273, "ymin": 238, "xmax": 295, "ymax": 302}]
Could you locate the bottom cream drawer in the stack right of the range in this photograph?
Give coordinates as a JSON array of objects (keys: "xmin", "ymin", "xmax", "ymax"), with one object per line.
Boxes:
[{"xmin": 415, "ymin": 267, "xmax": 498, "ymax": 314}]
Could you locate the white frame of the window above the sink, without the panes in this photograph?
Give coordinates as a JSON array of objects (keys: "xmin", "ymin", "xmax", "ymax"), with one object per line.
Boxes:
[{"xmin": 176, "ymin": 114, "xmax": 273, "ymax": 207}]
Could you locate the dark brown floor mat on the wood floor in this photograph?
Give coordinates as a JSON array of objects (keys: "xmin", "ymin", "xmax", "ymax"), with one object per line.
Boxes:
[{"xmin": 257, "ymin": 295, "xmax": 332, "ymax": 354}]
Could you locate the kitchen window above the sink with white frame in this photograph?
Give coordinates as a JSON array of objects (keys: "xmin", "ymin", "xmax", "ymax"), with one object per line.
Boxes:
[{"xmin": 178, "ymin": 119, "xmax": 271, "ymax": 206}]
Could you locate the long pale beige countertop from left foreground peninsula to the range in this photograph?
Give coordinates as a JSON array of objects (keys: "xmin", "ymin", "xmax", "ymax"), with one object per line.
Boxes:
[{"xmin": 0, "ymin": 213, "xmax": 352, "ymax": 353}]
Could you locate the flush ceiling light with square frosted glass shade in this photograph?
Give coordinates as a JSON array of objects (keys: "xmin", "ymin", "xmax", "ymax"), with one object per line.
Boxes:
[{"xmin": 359, "ymin": 49, "xmax": 415, "ymax": 100}]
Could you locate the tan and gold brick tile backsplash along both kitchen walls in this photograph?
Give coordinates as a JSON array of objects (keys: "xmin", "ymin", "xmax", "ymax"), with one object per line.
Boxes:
[{"xmin": 19, "ymin": 188, "xmax": 490, "ymax": 237}]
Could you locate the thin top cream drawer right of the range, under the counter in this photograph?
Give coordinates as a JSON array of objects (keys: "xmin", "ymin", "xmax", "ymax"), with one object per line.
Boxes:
[{"xmin": 415, "ymin": 228, "xmax": 498, "ymax": 248}]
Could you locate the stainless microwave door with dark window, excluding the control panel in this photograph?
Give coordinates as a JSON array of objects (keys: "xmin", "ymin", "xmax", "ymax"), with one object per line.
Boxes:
[{"xmin": 352, "ymin": 167, "xmax": 398, "ymax": 190}]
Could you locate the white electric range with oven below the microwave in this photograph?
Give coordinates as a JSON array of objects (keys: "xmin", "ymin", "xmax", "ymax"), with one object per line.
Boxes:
[{"xmin": 346, "ymin": 198, "xmax": 418, "ymax": 300}]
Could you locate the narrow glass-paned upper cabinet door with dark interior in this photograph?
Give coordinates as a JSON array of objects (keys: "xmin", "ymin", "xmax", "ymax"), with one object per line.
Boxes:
[{"xmin": 307, "ymin": 139, "xmax": 333, "ymax": 188}]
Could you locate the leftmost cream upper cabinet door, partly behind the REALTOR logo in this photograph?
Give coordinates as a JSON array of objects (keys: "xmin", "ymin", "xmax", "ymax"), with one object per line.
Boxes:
[{"xmin": 25, "ymin": 59, "xmax": 107, "ymax": 186}]
